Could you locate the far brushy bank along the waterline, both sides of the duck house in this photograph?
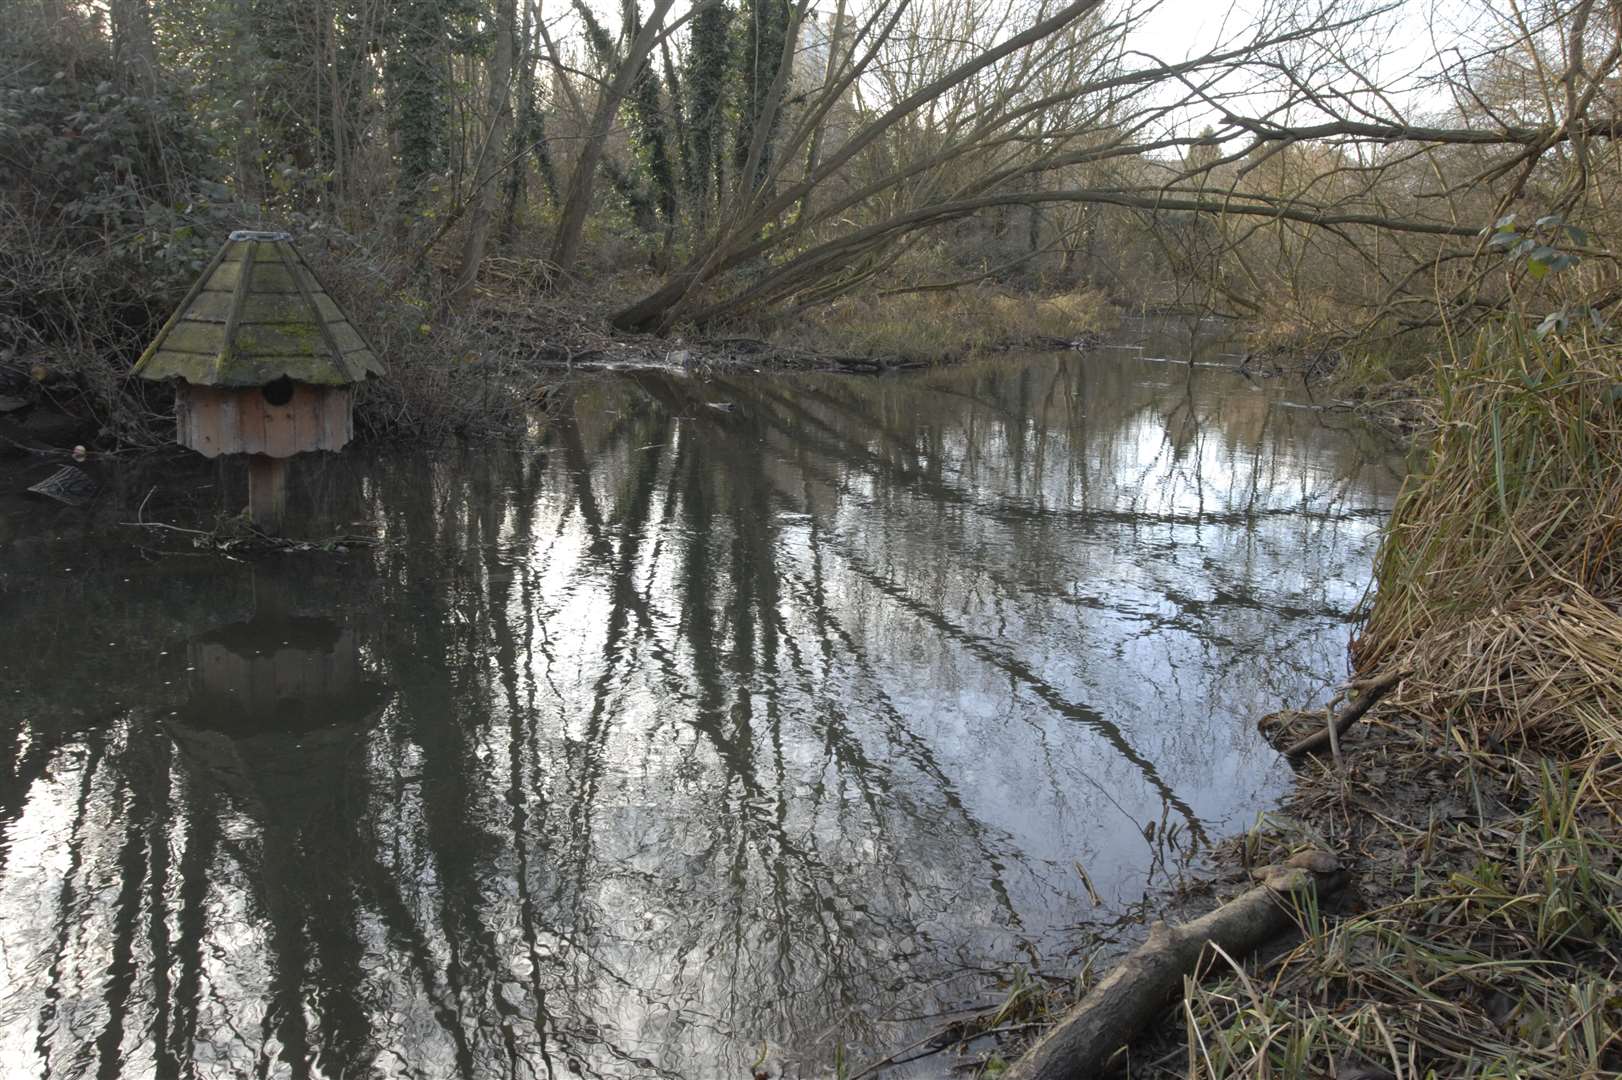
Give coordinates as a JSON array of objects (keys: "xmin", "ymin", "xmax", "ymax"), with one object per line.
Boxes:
[{"xmin": 0, "ymin": 230, "xmax": 1116, "ymax": 454}]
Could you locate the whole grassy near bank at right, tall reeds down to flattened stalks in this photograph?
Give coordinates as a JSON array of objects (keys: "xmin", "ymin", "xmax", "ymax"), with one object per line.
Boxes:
[{"xmin": 1137, "ymin": 326, "xmax": 1622, "ymax": 1080}]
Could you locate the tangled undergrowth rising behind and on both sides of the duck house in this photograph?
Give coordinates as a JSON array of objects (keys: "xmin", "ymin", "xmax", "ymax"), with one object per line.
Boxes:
[{"xmin": 0, "ymin": 28, "xmax": 524, "ymax": 451}]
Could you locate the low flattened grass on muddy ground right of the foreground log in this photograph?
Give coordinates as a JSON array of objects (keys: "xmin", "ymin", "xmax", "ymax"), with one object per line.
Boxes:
[{"xmin": 1161, "ymin": 738, "xmax": 1622, "ymax": 1080}]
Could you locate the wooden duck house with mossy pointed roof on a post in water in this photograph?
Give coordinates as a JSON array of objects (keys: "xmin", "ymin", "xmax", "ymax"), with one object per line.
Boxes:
[{"xmin": 135, "ymin": 230, "xmax": 383, "ymax": 530}]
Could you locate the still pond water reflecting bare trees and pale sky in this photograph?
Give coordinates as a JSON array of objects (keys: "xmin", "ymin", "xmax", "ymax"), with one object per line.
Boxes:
[{"xmin": 0, "ymin": 349, "xmax": 1400, "ymax": 1080}]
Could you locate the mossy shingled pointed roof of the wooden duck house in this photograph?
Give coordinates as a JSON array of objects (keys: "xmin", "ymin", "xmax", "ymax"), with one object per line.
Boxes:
[{"xmin": 135, "ymin": 232, "xmax": 383, "ymax": 388}]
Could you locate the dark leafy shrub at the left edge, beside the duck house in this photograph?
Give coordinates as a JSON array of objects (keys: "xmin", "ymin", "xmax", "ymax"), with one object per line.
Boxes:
[{"xmin": 0, "ymin": 18, "xmax": 237, "ymax": 443}]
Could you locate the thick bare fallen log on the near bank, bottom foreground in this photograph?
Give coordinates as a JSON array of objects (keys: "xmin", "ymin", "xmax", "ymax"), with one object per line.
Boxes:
[{"xmin": 1004, "ymin": 851, "xmax": 1345, "ymax": 1080}]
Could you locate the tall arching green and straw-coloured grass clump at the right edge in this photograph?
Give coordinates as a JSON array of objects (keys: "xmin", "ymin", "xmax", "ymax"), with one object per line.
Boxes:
[{"xmin": 1354, "ymin": 324, "xmax": 1622, "ymax": 765}]
